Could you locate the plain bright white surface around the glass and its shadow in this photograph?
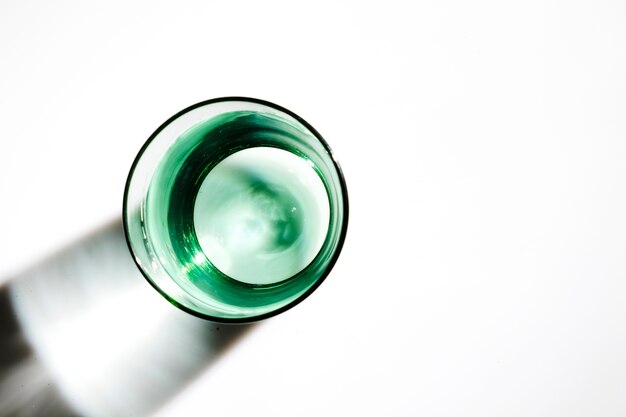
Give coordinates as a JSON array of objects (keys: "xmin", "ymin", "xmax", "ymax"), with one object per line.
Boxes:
[{"xmin": 0, "ymin": 0, "xmax": 626, "ymax": 417}]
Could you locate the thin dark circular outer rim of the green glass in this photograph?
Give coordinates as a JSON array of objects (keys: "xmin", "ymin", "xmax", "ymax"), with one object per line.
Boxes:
[{"xmin": 122, "ymin": 96, "xmax": 349, "ymax": 324}]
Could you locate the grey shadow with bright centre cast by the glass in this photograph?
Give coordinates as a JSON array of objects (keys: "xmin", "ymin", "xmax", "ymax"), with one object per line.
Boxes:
[{"xmin": 0, "ymin": 220, "xmax": 253, "ymax": 417}]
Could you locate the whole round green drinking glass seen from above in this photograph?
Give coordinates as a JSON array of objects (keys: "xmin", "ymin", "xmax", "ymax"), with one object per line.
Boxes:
[{"xmin": 124, "ymin": 97, "xmax": 348, "ymax": 322}]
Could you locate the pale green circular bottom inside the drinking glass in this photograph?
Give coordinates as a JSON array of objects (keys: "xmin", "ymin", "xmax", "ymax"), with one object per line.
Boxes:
[{"xmin": 194, "ymin": 147, "xmax": 330, "ymax": 285}]
